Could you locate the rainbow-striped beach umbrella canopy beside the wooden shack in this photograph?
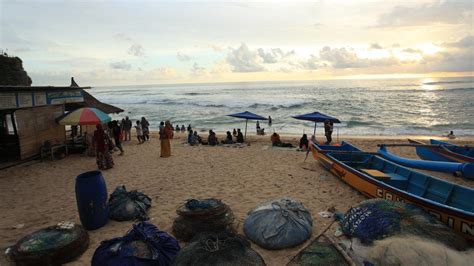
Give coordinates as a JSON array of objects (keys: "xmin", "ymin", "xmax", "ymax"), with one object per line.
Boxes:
[{"xmin": 58, "ymin": 107, "xmax": 112, "ymax": 126}]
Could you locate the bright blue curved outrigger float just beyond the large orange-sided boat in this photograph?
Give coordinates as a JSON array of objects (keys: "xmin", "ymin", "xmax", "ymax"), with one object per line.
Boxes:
[{"xmin": 378, "ymin": 144, "xmax": 474, "ymax": 179}]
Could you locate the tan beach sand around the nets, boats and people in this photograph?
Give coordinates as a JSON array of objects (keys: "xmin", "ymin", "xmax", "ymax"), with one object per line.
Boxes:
[{"xmin": 0, "ymin": 133, "xmax": 474, "ymax": 265}]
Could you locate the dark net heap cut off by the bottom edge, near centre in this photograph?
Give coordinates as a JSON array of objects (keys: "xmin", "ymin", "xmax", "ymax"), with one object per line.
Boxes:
[{"xmin": 173, "ymin": 231, "xmax": 265, "ymax": 266}]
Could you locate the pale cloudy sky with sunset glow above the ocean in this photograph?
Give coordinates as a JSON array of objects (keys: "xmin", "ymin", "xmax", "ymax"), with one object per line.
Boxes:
[{"xmin": 0, "ymin": 0, "xmax": 474, "ymax": 86}]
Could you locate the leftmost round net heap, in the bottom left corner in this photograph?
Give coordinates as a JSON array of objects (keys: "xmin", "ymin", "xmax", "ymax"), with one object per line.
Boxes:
[{"xmin": 9, "ymin": 222, "xmax": 89, "ymax": 265}]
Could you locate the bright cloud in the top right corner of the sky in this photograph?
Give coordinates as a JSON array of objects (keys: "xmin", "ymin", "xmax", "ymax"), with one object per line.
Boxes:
[{"xmin": 376, "ymin": 0, "xmax": 473, "ymax": 27}]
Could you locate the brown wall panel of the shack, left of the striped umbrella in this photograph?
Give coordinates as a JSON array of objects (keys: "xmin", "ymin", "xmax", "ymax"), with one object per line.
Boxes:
[{"xmin": 15, "ymin": 105, "xmax": 66, "ymax": 160}]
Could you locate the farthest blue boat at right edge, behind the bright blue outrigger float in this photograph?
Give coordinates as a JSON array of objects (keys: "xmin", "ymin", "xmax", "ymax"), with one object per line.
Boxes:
[{"xmin": 408, "ymin": 139, "xmax": 474, "ymax": 163}]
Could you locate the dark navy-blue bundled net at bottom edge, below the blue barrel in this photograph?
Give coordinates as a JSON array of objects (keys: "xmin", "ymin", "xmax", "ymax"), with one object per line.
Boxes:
[{"xmin": 91, "ymin": 222, "xmax": 180, "ymax": 266}]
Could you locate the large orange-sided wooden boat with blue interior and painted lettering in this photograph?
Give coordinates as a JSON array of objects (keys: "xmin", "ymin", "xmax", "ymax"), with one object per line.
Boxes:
[{"xmin": 311, "ymin": 144, "xmax": 474, "ymax": 241}]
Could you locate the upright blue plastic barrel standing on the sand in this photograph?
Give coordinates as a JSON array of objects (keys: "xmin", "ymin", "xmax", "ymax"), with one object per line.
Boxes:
[{"xmin": 76, "ymin": 171, "xmax": 109, "ymax": 230}]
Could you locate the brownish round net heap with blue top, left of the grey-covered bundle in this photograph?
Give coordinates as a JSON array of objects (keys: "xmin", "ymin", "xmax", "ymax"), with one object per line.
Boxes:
[{"xmin": 173, "ymin": 199, "xmax": 235, "ymax": 241}]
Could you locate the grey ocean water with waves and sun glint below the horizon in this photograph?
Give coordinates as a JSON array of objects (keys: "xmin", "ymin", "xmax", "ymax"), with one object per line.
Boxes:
[{"xmin": 89, "ymin": 77, "xmax": 474, "ymax": 136}]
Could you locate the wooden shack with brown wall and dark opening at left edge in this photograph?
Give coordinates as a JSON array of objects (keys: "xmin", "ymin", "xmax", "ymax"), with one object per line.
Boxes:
[{"xmin": 0, "ymin": 86, "xmax": 89, "ymax": 162}]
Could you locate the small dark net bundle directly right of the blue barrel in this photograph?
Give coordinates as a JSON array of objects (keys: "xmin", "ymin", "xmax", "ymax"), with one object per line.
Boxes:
[{"xmin": 109, "ymin": 186, "xmax": 151, "ymax": 221}]
